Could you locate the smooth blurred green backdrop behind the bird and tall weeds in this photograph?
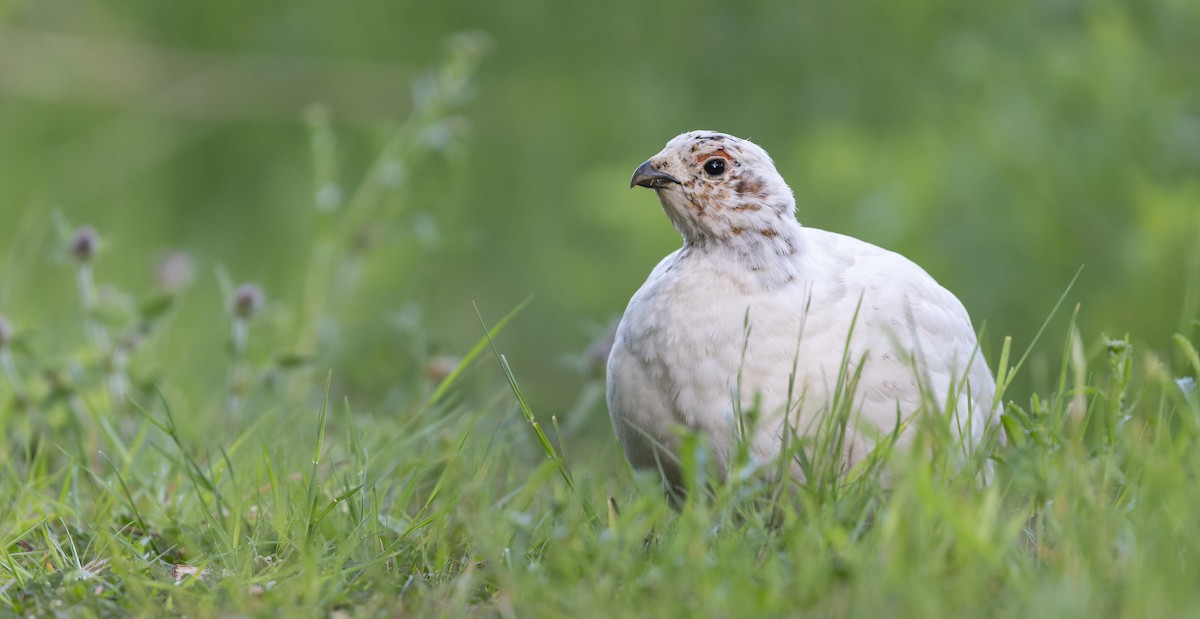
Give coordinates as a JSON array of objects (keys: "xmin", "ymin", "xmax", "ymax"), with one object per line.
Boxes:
[{"xmin": 0, "ymin": 0, "xmax": 1200, "ymax": 423}]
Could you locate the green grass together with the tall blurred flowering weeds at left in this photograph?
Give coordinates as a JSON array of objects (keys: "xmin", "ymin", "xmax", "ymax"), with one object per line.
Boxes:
[{"xmin": 0, "ymin": 32, "xmax": 1200, "ymax": 618}]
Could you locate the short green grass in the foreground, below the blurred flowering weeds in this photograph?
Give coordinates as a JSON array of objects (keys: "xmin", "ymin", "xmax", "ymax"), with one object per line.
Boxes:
[{"xmin": 0, "ymin": 267, "xmax": 1200, "ymax": 617}]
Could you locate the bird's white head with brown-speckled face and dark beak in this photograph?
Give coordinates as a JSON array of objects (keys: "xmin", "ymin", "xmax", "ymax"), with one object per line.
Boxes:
[{"xmin": 629, "ymin": 131, "xmax": 799, "ymax": 244}]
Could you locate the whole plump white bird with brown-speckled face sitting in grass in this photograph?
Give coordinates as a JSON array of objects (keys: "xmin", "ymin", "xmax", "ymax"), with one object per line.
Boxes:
[{"xmin": 607, "ymin": 131, "xmax": 995, "ymax": 488}]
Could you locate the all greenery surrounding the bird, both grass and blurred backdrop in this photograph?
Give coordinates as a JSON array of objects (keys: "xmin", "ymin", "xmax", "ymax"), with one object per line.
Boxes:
[{"xmin": 0, "ymin": 0, "xmax": 1200, "ymax": 618}]
